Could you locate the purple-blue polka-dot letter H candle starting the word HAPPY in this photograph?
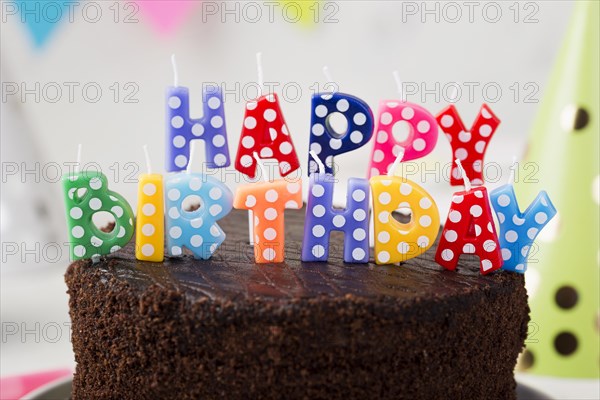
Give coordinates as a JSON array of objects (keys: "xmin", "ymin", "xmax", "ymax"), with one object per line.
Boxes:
[{"xmin": 165, "ymin": 86, "xmax": 230, "ymax": 172}]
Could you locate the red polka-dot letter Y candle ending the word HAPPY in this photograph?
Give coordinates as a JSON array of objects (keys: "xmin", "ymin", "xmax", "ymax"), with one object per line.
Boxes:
[{"xmin": 436, "ymin": 104, "xmax": 500, "ymax": 186}]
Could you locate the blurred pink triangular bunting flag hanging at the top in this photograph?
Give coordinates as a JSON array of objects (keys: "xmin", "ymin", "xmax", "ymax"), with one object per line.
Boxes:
[{"xmin": 137, "ymin": 0, "xmax": 200, "ymax": 34}]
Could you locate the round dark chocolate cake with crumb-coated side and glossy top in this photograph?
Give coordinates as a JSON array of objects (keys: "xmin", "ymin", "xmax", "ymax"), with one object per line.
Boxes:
[{"xmin": 66, "ymin": 210, "xmax": 529, "ymax": 400}]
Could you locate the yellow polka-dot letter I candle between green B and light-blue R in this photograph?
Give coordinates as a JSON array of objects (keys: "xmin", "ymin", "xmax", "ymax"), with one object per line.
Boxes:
[{"xmin": 135, "ymin": 174, "xmax": 165, "ymax": 262}]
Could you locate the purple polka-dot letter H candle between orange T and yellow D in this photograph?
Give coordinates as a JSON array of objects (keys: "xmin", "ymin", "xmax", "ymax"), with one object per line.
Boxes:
[{"xmin": 302, "ymin": 173, "xmax": 369, "ymax": 263}]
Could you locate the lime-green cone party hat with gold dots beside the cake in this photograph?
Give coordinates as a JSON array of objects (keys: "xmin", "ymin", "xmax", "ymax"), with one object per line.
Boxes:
[{"xmin": 516, "ymin": 1, "xmax": 600, "ymax": 378}]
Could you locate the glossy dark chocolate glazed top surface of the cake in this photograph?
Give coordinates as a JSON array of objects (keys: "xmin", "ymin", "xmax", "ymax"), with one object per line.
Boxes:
[{"xmin": 71, "ymin": 209, "xmax": 517, "ymax": 300}]
